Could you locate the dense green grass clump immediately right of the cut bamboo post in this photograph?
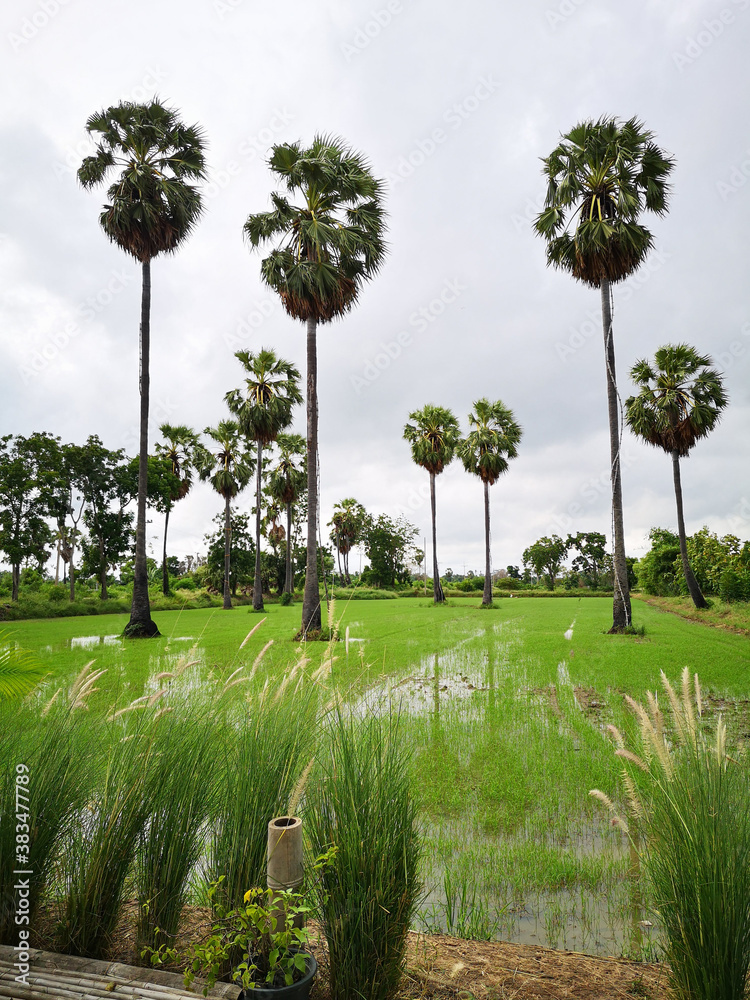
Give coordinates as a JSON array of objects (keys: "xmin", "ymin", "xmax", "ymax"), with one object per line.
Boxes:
[{"xmin": 304, "ymin": 709, "xmax": 422, "ymax": 1000}]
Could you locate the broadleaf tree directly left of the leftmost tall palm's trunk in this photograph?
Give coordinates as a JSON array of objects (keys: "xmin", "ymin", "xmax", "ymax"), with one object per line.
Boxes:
[{"xmin": 78, "ymin": 434, "xmax": 139, "ymax": 601}]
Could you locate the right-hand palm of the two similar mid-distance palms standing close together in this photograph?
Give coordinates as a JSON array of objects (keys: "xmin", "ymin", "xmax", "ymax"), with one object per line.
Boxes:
[{"xmin": 456, "ymin": 399, "xmax": 523, "ymax": 607}]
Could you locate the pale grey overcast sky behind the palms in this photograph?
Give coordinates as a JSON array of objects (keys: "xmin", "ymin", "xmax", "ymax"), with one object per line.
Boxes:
[{"xmin": 0, "ymin": 0, "xmax": 750, "ymax": 572}]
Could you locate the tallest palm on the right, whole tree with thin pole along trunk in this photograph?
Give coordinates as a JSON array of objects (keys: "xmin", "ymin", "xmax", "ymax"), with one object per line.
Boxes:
[{"xmin": 534, "ymin": 118, "xmax": 674, "ymax": 632}]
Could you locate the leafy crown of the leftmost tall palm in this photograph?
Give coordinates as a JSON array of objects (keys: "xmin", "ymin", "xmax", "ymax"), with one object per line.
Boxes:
[{"xmin": 78, "ymin": 100, "xmax": 206, "ymax": 263}]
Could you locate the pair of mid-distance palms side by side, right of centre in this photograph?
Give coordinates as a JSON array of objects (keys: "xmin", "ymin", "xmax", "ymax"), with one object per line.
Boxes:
[{"xmin": 404, "ymin": 399, "xmax": 522, "ymax": 607}]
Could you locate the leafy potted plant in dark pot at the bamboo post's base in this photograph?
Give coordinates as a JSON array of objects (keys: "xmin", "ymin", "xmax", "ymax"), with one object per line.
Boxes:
[{"xmin": 143, "ymin": 877, "xmax": 317, "ymax": 1000}]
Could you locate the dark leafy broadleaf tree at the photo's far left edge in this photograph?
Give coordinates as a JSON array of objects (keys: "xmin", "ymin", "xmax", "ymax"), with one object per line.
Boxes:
[{"xmin": 0, "ymin": 432, "xmax": 60, "ymax": 601}]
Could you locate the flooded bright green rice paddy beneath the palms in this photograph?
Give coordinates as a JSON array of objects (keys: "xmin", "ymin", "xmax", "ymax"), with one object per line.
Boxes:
[{"xmin": 5, "ymin": 598, "xmax": 750, "ymax": 957}]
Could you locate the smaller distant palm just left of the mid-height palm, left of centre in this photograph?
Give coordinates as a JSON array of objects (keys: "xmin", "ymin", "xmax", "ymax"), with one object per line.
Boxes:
[{"xmin": 195, "ymin": 420, "xmax": 255, "ymax": 611}]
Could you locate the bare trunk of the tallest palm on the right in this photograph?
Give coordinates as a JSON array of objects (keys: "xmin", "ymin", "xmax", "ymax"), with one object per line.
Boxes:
[{"xmin": 601, "ymin": 278, "xmax": 632, "ymax": 632}]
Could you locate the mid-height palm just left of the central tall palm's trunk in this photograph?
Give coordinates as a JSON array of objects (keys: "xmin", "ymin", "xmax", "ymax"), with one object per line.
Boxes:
[{"xmin": 225, "ymin": 349, "xmax": 302, "ymax": 611}]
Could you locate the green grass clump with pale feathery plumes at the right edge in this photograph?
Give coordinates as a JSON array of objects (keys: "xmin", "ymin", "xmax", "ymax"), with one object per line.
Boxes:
[{"xmin": 591, "ymin": 668, "xmax": 750, "ymax": 1000}]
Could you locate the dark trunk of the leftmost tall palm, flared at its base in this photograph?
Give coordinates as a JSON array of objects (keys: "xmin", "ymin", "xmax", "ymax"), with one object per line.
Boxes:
[{"xmin": 126, "ymin": 260, "xmax": 159, "ymax": 638}]
